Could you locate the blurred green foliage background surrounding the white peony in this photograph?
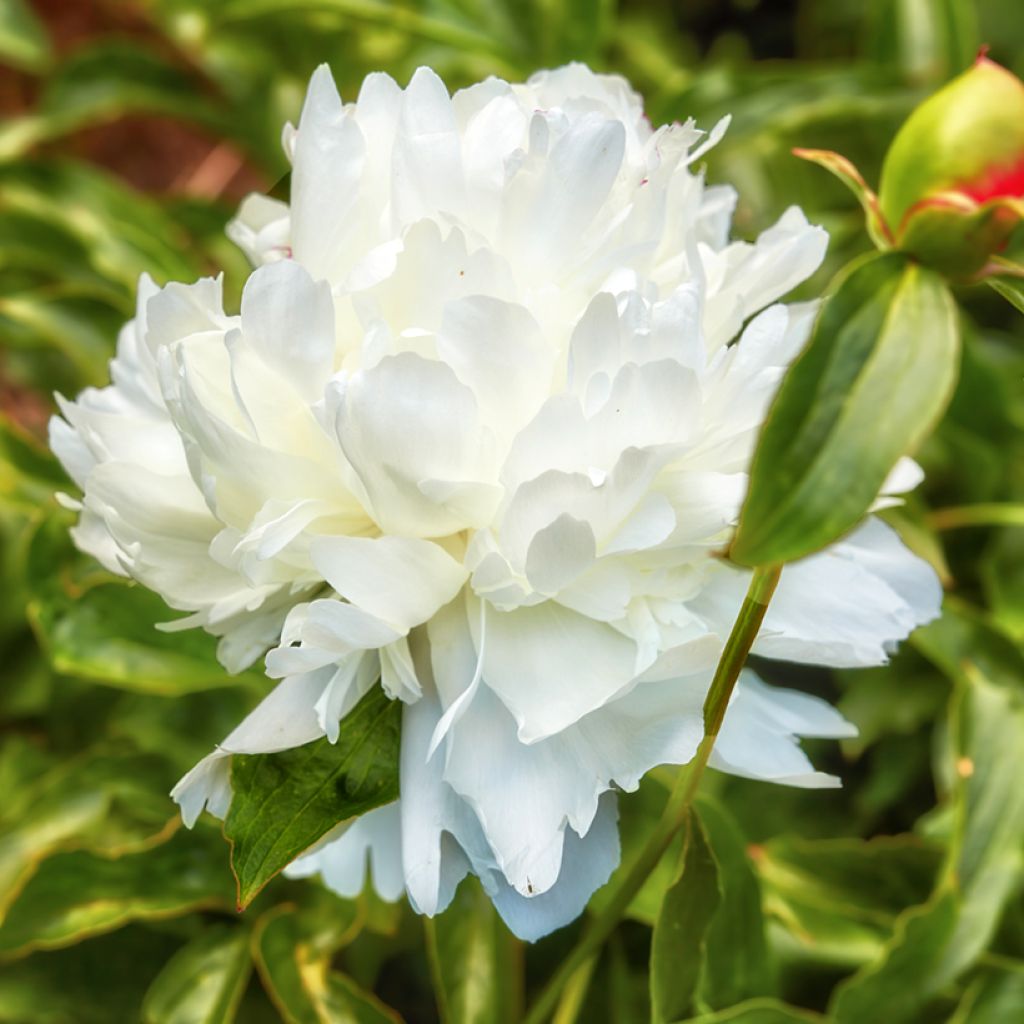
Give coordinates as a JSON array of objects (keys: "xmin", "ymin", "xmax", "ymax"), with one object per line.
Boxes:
[{"xmin": 0, "ymin": 0, "xmax": 1024, "ymax": 1024}]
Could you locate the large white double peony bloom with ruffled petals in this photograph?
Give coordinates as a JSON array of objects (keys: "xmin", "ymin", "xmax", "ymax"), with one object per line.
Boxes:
[{"xmin": 52, "ymin": 65, "xmax": 940, "ymax": 939}]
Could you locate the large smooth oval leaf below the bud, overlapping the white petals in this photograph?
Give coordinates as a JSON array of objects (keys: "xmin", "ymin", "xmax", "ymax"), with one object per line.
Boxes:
[{"xmin": 730, "ymin": 253, "xmax": 959, "ymax": 565}]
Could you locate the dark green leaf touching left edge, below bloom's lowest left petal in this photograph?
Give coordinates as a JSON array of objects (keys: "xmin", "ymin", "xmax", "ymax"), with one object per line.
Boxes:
[{"xmin": 0, "ymin": 829, "xmax": 231, "ymax": 956}]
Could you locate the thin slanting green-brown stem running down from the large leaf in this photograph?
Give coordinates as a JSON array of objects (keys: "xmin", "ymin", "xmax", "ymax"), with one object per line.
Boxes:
[{"xmin": 523, "ymin": 565, "xmax": 782, "ymax": 1024}]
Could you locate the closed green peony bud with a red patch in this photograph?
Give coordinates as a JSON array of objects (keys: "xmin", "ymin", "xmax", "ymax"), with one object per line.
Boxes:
[{"xmin": 879, "ymin": 54, "xmax": 1024, "ymax": 278}]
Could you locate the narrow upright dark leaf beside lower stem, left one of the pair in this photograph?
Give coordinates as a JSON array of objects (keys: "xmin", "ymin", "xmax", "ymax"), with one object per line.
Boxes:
[{"xmin": 650, "ymin": 814, "xmax": 721, "ymax": 1024}]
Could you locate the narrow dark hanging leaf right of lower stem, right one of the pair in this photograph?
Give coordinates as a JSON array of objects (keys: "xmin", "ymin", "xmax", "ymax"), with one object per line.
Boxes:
[{"xmin": 697, "ymin": 798, "xmax": 772, "ymax": 1009}]
